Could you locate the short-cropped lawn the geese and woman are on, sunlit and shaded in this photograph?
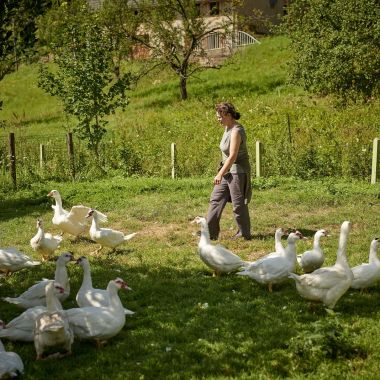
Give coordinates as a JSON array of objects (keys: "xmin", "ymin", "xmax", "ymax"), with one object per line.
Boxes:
[{"xmin": 0, "ymin": 177, "xmax": 380, "ymax": 380}]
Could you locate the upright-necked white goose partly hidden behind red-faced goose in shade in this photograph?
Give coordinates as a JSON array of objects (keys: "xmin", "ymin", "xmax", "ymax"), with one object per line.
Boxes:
[{"xmin": 76, "ymin": 256, "xmax": 134, "ymax": 315}]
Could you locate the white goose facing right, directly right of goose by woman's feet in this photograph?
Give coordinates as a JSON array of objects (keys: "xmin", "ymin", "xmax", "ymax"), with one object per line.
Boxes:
[{"xmin": 237, "ymin": 231, "xmax": 303, "ymax": 292}]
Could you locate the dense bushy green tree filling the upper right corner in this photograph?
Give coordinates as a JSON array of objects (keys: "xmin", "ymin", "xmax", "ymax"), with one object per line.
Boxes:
[{"xmin": 286, "ymin": 0, "xmax": 380, "ymax": 102}]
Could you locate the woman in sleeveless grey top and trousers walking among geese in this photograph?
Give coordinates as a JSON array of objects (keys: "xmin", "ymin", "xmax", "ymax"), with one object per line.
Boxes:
[{"xmin": 207, "ymin": 103, "xmax": 251, "ymax": 240}]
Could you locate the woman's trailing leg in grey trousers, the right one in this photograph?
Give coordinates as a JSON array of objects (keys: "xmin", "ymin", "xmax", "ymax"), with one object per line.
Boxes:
[{"xmin": 228, "ymin": 173, "xmax": 251, "ymax": 239}]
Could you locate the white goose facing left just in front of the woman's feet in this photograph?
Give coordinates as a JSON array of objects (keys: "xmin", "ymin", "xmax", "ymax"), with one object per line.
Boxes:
[{"xmin": 192, "ymin": 216, "xmax": 246, "ymax": 276}]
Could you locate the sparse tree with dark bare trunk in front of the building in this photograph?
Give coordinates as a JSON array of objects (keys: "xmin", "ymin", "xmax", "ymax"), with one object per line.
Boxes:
[{"xmin": 129, "ymin": 0, "xmax": 233, "ymax": 100}]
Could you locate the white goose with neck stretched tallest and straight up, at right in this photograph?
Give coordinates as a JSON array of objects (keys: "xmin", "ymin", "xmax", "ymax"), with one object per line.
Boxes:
[{"xmin": 289, "ymin": 221, "xmax": 354, "ymax": 309}]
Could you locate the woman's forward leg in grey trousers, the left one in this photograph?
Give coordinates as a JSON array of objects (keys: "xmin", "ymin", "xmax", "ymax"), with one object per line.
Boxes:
[{"xmin": 206, "ymin": 177, "xmax": 230, "ymax": 240}]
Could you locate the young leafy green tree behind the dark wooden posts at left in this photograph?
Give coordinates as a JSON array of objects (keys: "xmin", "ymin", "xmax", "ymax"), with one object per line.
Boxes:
[{"xmin": 39, "ymin": 0, "xmax": 131, "ymax": 157}]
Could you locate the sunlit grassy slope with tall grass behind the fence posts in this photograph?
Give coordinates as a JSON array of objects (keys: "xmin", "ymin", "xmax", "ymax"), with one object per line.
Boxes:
[{"xmin": 0, "ymin": 37, "xmax": 380, "ymax": 186}]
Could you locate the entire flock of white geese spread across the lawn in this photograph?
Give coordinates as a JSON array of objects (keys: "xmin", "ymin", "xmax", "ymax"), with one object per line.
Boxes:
[{"xmin": 0, "ymin": 190, "xmax": 380, "ymax": 378}]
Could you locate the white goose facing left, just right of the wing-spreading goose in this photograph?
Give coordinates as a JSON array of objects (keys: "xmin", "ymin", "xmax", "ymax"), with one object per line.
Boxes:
[{"xmin": 86, "ymin": 209, "xmax": 137, "ymax": 253}]
